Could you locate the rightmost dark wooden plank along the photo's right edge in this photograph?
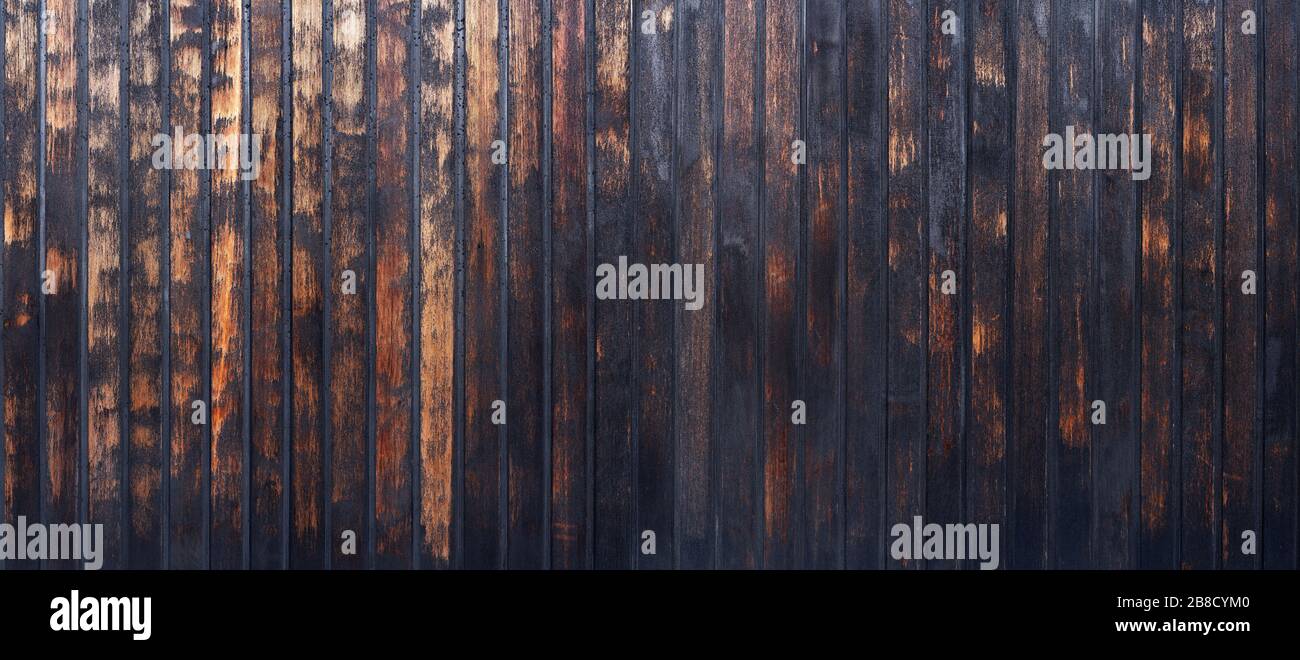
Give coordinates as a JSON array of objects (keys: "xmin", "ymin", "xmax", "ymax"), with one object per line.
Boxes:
[{"xmin": 1260, "ymin": 0, "xmax": 1300, "ymax": 569}]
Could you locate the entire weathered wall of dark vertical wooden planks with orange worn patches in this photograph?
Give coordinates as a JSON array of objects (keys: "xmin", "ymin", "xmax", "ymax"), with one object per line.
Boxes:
[{"xmin": 0, "ymin": 0, "xmax": 1300, "ymax": 569}]
